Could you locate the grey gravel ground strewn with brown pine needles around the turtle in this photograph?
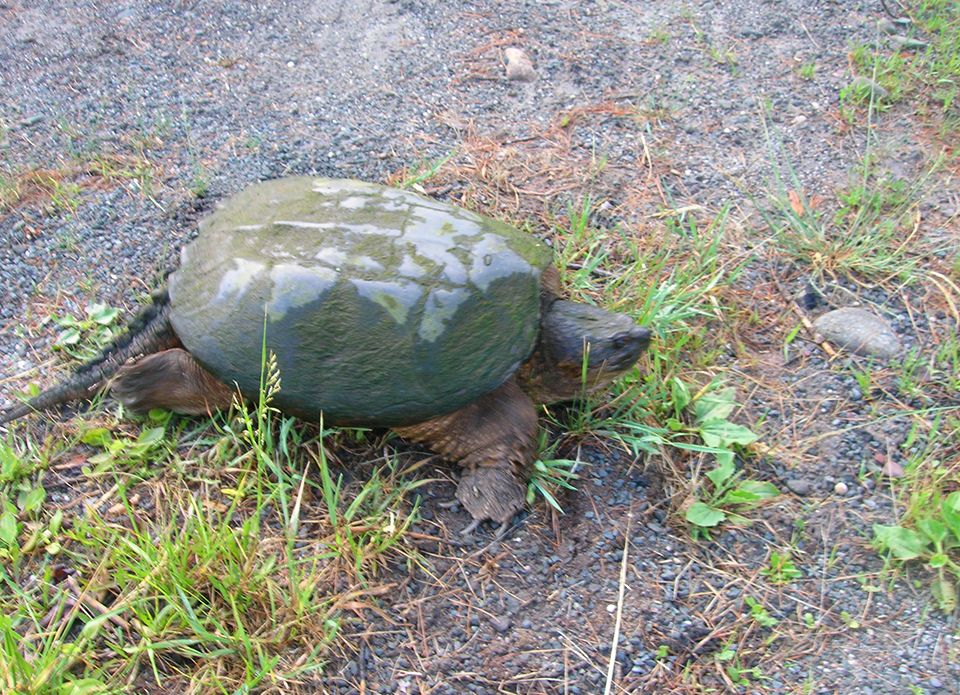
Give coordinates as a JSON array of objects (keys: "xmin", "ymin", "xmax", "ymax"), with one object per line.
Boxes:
[{"xmin": 0, "ymin": 0, "xmax": 960, "ymax": 694}]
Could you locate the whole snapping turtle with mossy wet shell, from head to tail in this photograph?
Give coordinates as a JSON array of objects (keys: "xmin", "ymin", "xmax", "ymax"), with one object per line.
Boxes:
[{"xmin": 0, "ymin": 177, "xmax": 650, "ymax": 528}]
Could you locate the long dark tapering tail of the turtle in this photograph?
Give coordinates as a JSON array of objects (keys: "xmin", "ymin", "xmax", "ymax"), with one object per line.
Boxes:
[{"xmin": 0, "ymin": 290, "xmax": 180, "ymax": 425}]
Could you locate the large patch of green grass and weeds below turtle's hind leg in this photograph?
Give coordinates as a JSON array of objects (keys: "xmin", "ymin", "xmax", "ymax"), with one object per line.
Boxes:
[{"xmin": 0, "ymin": 348, "xmax": 416, "ymax": 693}]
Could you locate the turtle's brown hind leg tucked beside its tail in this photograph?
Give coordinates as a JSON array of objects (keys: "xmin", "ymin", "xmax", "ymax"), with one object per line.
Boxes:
[{"xmin": 110, "ymin": 348, "xmax": 234, "ymax": 415}]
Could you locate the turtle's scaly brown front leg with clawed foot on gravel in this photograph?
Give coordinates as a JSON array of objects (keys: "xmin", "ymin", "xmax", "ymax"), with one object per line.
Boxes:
[{"xmin": 395, "ymin": 379, "xmax": 537, "ymax": 534}]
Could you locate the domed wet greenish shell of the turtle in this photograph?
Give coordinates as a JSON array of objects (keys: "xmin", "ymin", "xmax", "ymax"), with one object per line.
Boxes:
[{"xmin": 169, "ymin": 177, "xmax": 551, "ymax": 426}]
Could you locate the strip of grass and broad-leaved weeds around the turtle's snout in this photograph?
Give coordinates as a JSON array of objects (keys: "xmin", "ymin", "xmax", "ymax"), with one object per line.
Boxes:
[{"xmin": 528, "ymin": 200, "xmax": 779, "ymax": 537}]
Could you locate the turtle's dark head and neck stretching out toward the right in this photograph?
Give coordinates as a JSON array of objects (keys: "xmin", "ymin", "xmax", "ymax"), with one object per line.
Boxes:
[{"xmin": 518, "ymin": 300, "xmax": 650, "ymax": 403}]
